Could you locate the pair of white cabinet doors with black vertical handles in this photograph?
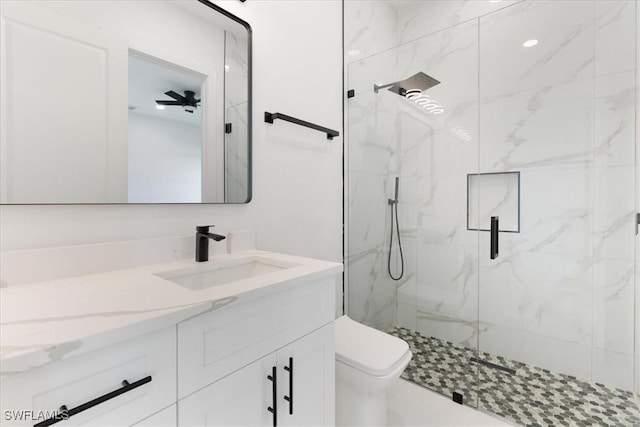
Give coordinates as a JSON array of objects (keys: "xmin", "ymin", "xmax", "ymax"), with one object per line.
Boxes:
[{"xmin": 178, "ymin": 324, "xmax": 334, "ymax": 427}]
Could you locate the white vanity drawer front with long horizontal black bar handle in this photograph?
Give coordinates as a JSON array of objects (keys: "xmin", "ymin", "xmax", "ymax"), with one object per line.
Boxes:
[{"xmin": 0, "ymin": 327, "xmax": 176, "ymax": 426}]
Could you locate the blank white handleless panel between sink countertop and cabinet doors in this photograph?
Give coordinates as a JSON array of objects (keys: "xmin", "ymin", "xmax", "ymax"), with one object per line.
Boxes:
[{"xmin": 178, "ymin": 277, "xmax": 336, "ymax": 398}]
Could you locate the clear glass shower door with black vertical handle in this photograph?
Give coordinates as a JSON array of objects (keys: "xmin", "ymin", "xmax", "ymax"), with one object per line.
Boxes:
[{"xmin": 475, "ymin": 1, "xmax": 640, "ymax": 425}]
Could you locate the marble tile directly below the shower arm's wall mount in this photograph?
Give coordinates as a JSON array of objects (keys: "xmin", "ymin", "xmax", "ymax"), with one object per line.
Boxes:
[{"xmin": 348, "ymin": 92, "xmax": 397, "ymax": 176}]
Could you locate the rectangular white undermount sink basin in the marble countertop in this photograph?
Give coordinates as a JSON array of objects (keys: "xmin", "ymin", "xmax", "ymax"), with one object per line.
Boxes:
[{"xmin": 154, "ymin": 256, "xmax": 298, "ymax": 291}]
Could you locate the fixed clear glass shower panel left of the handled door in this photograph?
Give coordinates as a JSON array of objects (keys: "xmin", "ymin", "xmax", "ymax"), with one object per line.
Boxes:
[{"xmin": 345, "ymin": 17, "xmax": 480, "ymax": 407}]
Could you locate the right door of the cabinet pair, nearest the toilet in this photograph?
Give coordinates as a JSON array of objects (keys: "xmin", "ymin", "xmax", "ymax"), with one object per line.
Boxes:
[{"xmin": 277, "ymin": 323, "xmax": 335, "ymax": 426}]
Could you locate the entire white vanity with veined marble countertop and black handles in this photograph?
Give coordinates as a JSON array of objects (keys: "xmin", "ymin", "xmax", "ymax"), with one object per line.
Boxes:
[{"xmin": 0, "ymin": 253, "xmax": 341, "ymax": 427}]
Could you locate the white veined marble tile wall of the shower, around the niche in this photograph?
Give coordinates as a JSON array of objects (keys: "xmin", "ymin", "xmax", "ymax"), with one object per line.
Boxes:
[{"xmin": 345, "ymin": 0, "xmax": 640, "ymax": 390}]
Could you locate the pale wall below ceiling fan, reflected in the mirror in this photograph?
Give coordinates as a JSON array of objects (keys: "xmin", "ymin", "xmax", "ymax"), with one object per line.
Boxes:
[{"xmin": 128, "ymin": 113, "xmax": 202, "ymax": 203}]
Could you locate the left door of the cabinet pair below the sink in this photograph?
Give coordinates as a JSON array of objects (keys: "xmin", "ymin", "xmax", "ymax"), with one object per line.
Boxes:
[{"xmin": 178, "ymin": 353, "xmax": 280, "ymax": 427}]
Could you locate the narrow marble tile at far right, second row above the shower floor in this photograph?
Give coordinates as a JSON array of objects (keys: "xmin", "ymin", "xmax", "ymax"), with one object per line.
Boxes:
[{"xmin": 593, "ymin": 259, "xmax": 635, "ymax": 355}]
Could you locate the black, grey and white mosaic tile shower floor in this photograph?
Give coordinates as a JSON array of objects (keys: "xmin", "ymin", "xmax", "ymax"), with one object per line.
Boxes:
[{"xmin": 389, "ymin": 328, "xmax": 640, "ymax": 426}]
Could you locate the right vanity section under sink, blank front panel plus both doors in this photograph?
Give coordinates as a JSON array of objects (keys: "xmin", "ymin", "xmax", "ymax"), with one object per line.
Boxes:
[{"xmin": 178, "ymin": 277, "xmax": 335, "ymax": 426}]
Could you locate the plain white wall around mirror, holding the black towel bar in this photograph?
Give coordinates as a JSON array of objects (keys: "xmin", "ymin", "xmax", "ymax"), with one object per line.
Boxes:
[{"xmin": 0, "ymin": 0, "xmax": 342, "ymax": 267}]
